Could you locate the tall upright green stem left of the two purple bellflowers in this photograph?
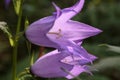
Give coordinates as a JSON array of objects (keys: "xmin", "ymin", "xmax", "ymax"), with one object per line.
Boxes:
[{"xmin": 12, "ymin": 0, "xmax": 22, "ymax": 80}]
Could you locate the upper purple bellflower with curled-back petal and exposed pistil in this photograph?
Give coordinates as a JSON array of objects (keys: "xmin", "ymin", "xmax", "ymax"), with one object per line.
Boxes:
[{"xmin": 26, "ymin": 0, "xmax": 101, "ymax": 48}]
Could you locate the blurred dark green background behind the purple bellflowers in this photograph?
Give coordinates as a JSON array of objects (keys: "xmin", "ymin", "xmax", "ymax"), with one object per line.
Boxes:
[{"xmin": 0, "ymin": 0, "xmax": 120, "ymax": 80}]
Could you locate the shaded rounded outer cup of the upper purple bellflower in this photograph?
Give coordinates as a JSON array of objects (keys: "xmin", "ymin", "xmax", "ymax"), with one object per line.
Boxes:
[{"xmin": 26, "ymin": 16, "xmax": 58, "ymax": 48}]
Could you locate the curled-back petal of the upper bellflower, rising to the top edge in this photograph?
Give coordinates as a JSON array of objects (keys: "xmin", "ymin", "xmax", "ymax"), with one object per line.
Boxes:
[{"xmin": 56, "ymin": 0, "xmax": 84, "ymax": 23}]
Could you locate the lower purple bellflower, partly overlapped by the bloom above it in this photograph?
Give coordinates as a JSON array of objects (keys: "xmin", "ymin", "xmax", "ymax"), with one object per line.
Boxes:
[{"xmin": 31, "ymin": 50, "xmax": 96, "ymax": 79}]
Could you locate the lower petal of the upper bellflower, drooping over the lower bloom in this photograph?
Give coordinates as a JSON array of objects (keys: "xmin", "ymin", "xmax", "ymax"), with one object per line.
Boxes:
[{"xmin": 47, "ymin": 34, "xmax": 94, "ymax": 61}]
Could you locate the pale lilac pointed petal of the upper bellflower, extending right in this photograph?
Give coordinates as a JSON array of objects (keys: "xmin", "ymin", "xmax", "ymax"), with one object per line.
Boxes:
[{"xmin": 47, "ymin": 20, "xmax": 102, "ymax": 43}]
